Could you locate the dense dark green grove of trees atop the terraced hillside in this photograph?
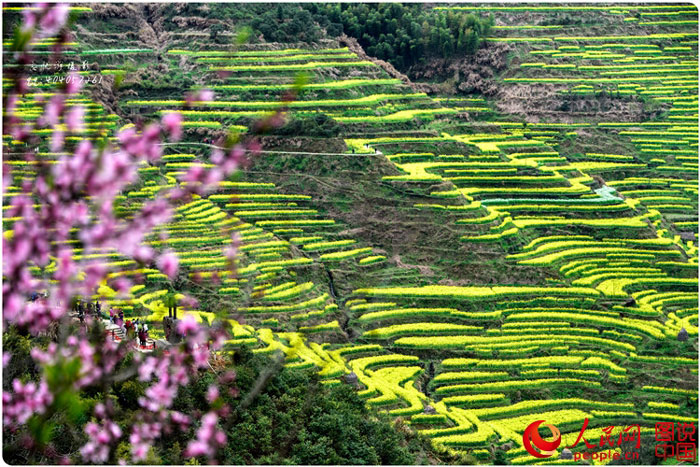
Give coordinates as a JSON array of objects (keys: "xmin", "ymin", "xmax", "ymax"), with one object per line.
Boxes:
[{"xmin": 190, "ymin": 3, "xmax": 493, "ymax": 69}]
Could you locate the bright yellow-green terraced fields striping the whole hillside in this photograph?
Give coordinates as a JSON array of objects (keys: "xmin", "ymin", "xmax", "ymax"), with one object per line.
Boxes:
[{"xmin": 3, "ymin": 4, "xmax": 698, "ymax": 464}]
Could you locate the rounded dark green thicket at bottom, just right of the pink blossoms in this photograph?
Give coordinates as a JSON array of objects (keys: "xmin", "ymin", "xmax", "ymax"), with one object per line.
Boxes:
[{"xmin": 223, "ymin": 356, "xmax": 434, "ymax": 464}]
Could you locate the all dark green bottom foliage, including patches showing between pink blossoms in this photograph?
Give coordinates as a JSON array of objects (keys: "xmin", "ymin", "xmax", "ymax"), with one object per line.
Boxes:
[{"xmin": 3, "ymin": 329, "xmax": 446, "ymax": 465}]
